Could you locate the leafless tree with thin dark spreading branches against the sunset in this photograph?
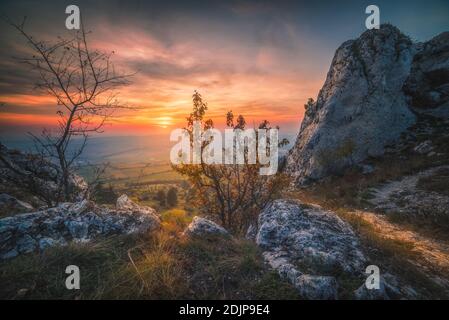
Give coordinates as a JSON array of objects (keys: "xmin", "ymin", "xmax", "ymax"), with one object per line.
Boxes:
[{"xmin": 3, "ymin": 19, "xmax": 133, "ymax": 201}]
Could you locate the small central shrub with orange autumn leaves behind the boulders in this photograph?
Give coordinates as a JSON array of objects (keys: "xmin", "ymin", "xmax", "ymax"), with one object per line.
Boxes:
[{"xmin": 173, "ymin": 91, "xmax": 289, "ymax": 233}]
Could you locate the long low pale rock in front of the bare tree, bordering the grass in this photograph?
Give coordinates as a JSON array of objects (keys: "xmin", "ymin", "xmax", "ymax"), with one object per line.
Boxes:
[{"xmin": 0, "ymin": 196, "xmax": 160, "ymax": 259}]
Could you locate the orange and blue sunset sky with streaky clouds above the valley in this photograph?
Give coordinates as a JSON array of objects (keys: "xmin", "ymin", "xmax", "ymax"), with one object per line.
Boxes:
[{"xmin": 0, "ymin": 0, "xmax": 449, "ymax": 135}]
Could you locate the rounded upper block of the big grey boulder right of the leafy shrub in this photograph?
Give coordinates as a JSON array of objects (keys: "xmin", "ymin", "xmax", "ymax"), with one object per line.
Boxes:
[{"xmin": 256, "ymin": 200, "xmax": 366, "ymax": 272}]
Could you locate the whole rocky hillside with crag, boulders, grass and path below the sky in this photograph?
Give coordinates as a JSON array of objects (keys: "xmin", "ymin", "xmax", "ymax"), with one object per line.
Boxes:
[{"xmin": 0, "ymin": 25, "xmax": 449, "ymax": 299}]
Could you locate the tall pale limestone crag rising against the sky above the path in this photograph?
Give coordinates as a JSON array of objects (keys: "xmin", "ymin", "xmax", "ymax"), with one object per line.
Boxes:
[{"xmin": 285, "ymin": 25, "xmax": 417, "ymax": 185}]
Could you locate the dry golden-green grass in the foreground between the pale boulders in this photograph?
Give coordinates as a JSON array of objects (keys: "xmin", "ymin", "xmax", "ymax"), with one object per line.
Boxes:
[{"xmin": 0, "ymin": 209, "xmax": 298, "ymax": 299}]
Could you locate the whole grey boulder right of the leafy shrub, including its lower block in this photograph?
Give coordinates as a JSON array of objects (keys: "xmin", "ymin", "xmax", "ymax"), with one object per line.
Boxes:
[{"xmin": 256, "ymin": 200, "xmax": 367, "ymax": 299}]
